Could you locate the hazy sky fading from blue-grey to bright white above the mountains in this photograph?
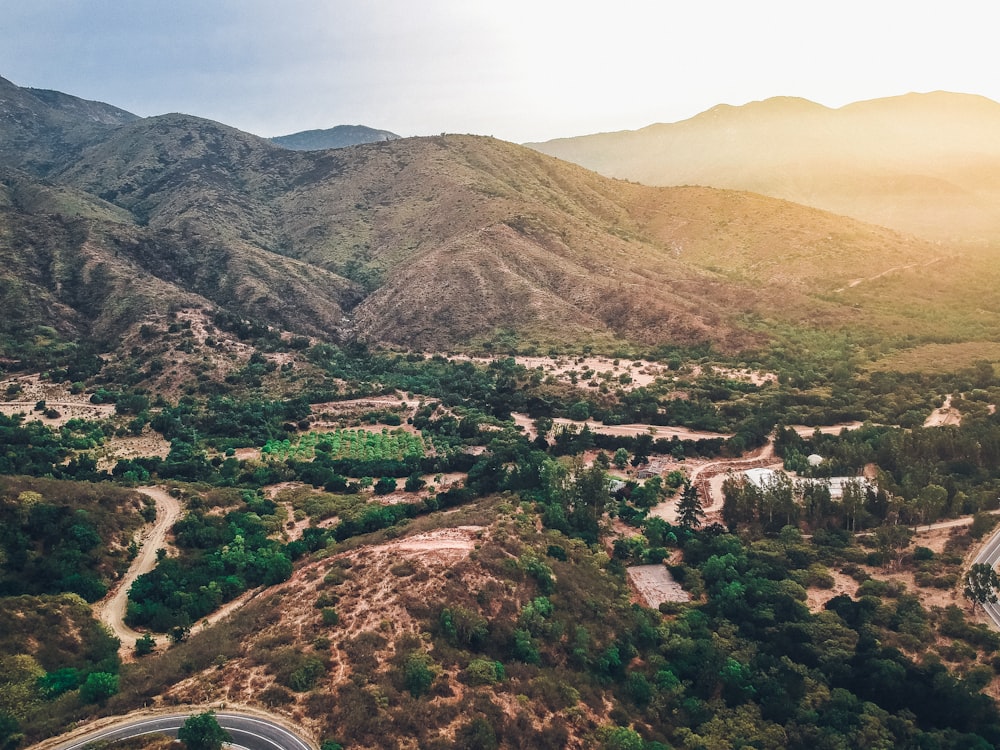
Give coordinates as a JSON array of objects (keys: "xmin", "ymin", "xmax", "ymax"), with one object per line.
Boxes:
[{"xmin": 0, "ymin": 0, "xmax": 1000, "ymax": 142}]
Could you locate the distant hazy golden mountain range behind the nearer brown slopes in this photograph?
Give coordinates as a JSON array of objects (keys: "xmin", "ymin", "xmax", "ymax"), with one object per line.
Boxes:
[{"xmin": 528, "ymin": 92, "xmax": 1000, "ymax": 241}]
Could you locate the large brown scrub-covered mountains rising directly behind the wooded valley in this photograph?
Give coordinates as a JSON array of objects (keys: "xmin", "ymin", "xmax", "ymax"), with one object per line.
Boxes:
[{"xmin": 0, "ymin": 76, "xmax": 972, "ymax": 362}]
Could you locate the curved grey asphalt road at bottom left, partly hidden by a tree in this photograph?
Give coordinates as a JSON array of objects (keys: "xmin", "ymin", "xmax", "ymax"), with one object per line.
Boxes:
[{"xmin": 46, "ymin": 711, "xmax": 313, "ymax": 750}]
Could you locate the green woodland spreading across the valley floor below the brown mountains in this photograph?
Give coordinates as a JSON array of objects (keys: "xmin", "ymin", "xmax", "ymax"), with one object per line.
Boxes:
[{"xmin": 0, "ymin": 341, "xmax": 1000, "ymax": 750}]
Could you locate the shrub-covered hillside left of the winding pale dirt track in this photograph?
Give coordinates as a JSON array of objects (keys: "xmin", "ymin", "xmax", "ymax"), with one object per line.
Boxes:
[{"xmin": 0, "ymin": 476, "xmax": 147, "ymax": 748}]
